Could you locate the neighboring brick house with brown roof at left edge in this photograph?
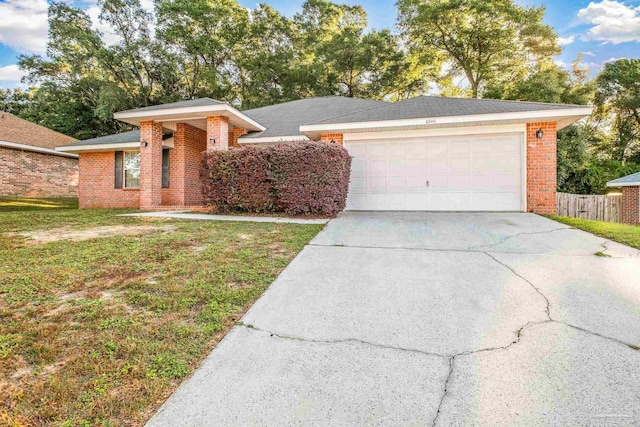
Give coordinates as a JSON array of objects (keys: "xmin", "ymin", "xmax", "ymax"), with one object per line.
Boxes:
[{"xmin": 0, "ymin": 111, "xmax": 78, "ymax": 197}]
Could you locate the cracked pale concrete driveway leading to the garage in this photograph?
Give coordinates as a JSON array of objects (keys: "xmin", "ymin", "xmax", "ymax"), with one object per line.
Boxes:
[{"xmin": 149, "ymin": 213, "xmax": 640, "ymax": 426}]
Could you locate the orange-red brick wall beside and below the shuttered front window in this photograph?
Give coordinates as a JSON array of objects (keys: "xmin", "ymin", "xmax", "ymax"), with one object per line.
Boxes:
[{"xmin": 78, "ymin": 151, "xmax": 140, "ymax": 208}]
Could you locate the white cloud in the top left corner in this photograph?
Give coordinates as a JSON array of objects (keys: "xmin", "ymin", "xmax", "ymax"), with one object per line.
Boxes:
[{"xmin": 0, "ymin": 0, "xmax": 49, "ymax": 53}]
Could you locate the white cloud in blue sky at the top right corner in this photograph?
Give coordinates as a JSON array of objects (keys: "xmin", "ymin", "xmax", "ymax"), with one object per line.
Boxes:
[{"xmin": 578, "ymin": 0, "xmax": 640, "ymax": 44}]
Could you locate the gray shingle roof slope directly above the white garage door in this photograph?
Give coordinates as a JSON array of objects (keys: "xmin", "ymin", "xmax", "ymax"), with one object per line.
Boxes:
[{"xmin": 305, "ymin": 96, "xmax": 585, "ymax": 124}]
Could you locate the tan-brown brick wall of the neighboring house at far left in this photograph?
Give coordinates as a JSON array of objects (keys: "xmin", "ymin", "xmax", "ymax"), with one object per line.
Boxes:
[{"xmin": 0, "ymin": 147, "xmax": 78, "ymax": 197}]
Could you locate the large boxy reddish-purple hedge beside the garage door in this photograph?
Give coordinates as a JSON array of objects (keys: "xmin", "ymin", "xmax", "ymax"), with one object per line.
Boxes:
[{"xmin": 201, "ymin": 141, "xmax": 351, "ymax": 215}]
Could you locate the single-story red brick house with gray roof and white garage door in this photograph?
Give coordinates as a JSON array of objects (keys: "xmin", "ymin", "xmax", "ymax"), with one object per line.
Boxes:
[{"xmin": 57, "ymin": 96, "xmax": 591, "ymax": 214}]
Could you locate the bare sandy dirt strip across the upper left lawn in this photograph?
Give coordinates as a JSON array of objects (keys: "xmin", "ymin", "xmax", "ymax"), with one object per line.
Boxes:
[{"xmin": 10, "ymin": 225, "xmax": 175, "ymax": 245}]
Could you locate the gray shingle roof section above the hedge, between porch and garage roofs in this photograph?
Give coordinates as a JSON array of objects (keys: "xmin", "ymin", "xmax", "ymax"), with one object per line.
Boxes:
[{"xmin": 241, "ymin": 96, "xmax": 388, "ymax": 138}]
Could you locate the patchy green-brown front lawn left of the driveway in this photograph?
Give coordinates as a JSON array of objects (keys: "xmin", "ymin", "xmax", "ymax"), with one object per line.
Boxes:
[{"xmin": 0, "ymin": 202, "xmax": 322, "ymax": 426}]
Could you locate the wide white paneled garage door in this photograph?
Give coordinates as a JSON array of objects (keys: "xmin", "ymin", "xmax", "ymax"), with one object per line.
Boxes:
[{"xmin": 345, "ymin": 135, "xmax": 522, "ymax": 211}]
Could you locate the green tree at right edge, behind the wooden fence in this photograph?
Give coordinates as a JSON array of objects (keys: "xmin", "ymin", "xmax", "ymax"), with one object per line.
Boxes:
[{"xmin": 594, "ymin": 59, "xmax": 640, "ymax": 161}]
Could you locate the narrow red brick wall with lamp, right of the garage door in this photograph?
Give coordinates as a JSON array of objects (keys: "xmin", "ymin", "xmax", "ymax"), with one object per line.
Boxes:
[{"xmin": 527, "ymin": 122, "xmax": 557, "ymax": 215}]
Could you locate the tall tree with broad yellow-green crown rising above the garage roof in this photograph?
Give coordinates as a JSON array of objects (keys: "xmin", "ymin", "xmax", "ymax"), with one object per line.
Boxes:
[{"xmin": 398, "ymin": 0, "xmax": 560, "ymax": 98}]
